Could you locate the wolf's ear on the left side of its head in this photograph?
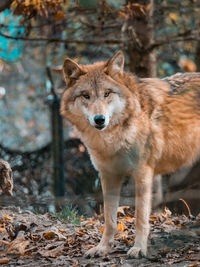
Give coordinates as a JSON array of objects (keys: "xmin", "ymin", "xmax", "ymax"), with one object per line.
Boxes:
[{"xmin": 63, "ymin": 58, "xmax": 85, "ymax": 86}]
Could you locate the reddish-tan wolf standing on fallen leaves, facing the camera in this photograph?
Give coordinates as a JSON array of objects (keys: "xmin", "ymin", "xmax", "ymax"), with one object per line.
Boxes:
[{"xmin": 61, "ymin": 51, "xmax": 200, "ymax": 258}]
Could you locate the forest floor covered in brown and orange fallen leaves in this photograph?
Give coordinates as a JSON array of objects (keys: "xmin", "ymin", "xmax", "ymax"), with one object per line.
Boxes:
[{"xmin": 0, "ymin": 207, "xmax": 200, "ymax": 267}]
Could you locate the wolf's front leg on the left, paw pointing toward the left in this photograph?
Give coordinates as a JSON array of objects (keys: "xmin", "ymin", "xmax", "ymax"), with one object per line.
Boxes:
[{"xmin": 86, "ymin": 173, "xmax": 122, "ymax": 256}]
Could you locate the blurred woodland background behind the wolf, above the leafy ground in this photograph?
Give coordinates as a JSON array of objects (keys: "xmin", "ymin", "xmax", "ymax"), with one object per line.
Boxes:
[{"xmin": 0, "ymin": 0, "xmax": 200, "ymax": 215}]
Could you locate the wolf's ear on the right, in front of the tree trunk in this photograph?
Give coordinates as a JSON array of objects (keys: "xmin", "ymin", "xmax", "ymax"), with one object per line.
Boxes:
[{"xmin": 105, "ymin": 51, "xmax": 124, "ymax": 75}]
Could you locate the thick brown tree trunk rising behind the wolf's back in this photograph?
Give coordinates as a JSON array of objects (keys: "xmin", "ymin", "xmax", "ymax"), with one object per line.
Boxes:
[{"xmin": 128, "ymin": 0, "xmax": 156, "ymax": 77}]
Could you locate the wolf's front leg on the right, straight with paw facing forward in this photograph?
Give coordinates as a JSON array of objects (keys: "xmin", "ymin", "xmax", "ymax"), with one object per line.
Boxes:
[{"xmin": 128, "ymin": 166, "xmax": 153, "ymax": 258}]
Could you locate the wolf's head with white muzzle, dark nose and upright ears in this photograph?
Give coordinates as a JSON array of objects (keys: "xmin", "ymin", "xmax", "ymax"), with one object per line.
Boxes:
[{"xmin": 61, "ymin": 51, "xmax": 132, "ymax": 130}]
